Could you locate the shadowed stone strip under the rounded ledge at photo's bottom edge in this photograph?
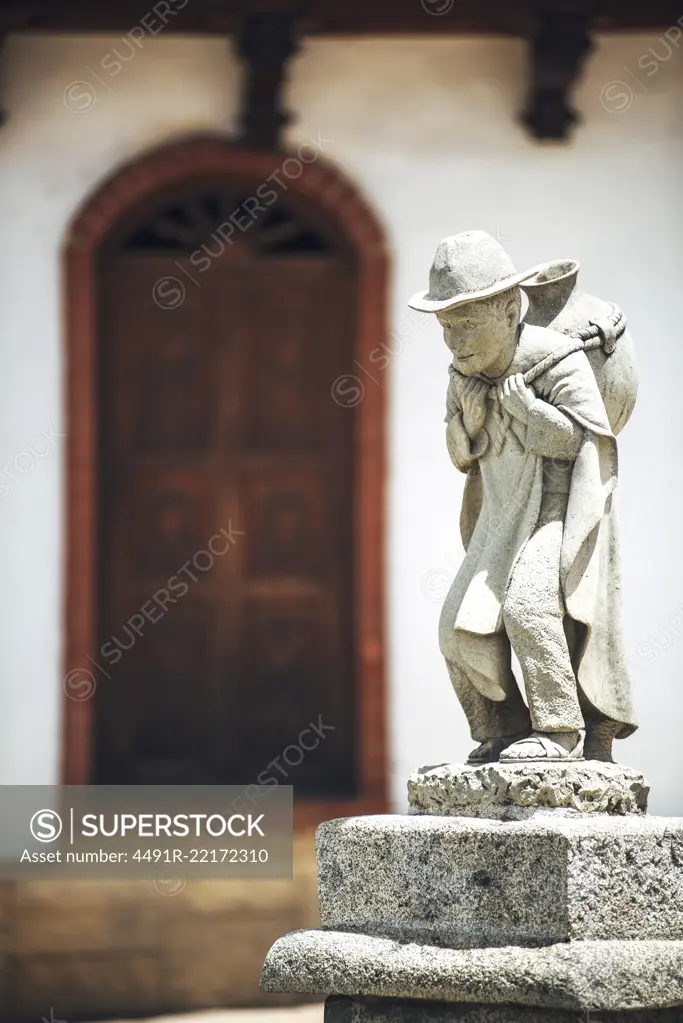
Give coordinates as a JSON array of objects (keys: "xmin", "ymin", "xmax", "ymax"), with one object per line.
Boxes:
[{"xmin": 325, "ymin": 995, "xmax": 682, "ymax": 1023}]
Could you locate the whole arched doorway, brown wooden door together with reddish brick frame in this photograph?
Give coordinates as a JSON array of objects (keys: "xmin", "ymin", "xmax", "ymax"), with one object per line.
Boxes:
[{"xmin": 64, "ymin": 139, "xmax": 385, "ymax": 816}]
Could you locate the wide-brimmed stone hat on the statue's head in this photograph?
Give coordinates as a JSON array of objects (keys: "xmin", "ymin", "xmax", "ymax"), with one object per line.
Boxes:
[{"xmin": 408, "ymin": 231, "xmax": 539, "ymax": 313}]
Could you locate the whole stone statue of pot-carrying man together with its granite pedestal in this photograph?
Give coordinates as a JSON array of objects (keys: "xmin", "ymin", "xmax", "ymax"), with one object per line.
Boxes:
[{"xmin": 262, "ymin": 231, "xmax": 683, "ymax": 1023}]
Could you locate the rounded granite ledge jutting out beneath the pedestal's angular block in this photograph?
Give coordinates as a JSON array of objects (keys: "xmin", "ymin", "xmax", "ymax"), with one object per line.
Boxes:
[{"xmin": 261, "ymin": 931, "xmax": 683, "ymax": 1019}]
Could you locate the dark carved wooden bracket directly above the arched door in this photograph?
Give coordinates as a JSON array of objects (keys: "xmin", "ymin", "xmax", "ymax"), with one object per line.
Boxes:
[{"xmin": 236, "ymin": 13, "xmax": 299, "ymax": 150}]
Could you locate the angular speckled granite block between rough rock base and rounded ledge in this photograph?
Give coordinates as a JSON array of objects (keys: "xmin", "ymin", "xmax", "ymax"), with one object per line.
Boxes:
[{"xmin": 318, "ymin": 814, "xmax": 683, "ymax": 948}]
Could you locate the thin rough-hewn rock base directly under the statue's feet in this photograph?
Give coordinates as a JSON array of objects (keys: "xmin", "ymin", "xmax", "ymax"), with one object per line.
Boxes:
[{"xmin": 408, "ymin": 760, "xmax": 649, "ymax": 819}]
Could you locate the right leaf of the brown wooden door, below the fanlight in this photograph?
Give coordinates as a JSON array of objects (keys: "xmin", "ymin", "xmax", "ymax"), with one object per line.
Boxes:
[{"xmin": 232, "ymin": 262, "xmax": 354, "ymax": 795}]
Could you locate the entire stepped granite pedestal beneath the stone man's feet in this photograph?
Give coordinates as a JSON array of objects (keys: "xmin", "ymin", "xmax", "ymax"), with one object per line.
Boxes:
[{"xmin": 262, "ymin": 762, "xmax": 683, "ymax": 1023}]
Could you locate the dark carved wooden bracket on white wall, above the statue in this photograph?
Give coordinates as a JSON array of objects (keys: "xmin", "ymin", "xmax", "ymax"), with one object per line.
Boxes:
[{"xmin": 521, "ymin": 2, "xmax": 593, "ymax": 139}]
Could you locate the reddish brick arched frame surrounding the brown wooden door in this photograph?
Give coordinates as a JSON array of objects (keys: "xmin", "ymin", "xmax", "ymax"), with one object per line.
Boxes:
[{"xmin": 61, "ymin": 137, "xmax": 389, "ymax": 826}]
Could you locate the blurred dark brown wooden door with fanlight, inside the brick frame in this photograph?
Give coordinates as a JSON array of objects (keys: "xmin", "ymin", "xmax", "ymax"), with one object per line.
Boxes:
[{"xmin": 96, "ymin": 188, "xmax": 356, "ymax": 796}]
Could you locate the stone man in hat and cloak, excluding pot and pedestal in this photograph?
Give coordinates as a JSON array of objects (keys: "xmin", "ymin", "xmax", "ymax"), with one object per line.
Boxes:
[{"xmin": 410, "ymin": 231, "xmax": 636, "ymax": 763}]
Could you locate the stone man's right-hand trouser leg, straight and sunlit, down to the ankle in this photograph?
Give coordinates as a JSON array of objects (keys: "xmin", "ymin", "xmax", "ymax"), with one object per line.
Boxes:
[{"xmin": 503, "ymin": 494, "xmax": 584, "ymax": 732}]
